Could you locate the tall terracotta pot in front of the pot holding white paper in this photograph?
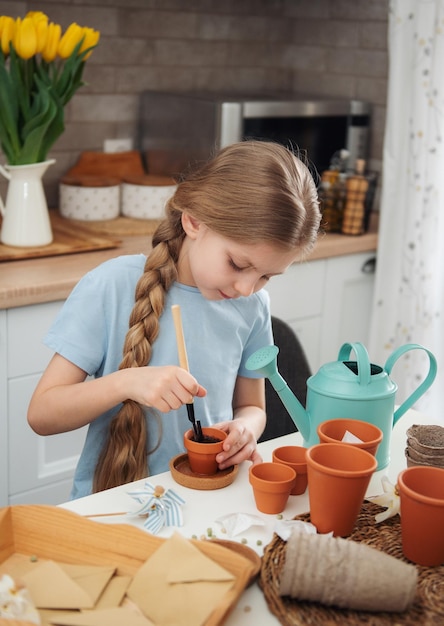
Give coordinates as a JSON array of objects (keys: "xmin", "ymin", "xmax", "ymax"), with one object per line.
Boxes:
[{"xmin": 307, "ymin": 443, "xmax": 378, "ymax": 537}]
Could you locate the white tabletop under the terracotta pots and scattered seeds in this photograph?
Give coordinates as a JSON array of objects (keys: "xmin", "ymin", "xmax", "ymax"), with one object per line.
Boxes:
[{"xmin": 60, "ymin": 410, "xmax": 438, "ymax": 626}]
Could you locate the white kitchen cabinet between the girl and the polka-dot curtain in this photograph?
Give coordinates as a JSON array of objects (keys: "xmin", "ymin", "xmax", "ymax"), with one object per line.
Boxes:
[{"xmin": 267, "ymin": 252, "xmax": 376, "ymax": 372}]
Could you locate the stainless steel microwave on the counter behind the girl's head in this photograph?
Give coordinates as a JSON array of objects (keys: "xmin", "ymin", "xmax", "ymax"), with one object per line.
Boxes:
[{"xmin": 138, "ymin": 91, "xmax": 371, "ymax": 175}]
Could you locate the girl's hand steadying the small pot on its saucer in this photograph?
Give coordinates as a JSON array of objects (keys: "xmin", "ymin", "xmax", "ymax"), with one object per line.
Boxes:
[{"xmin": 215, "ymin": 417, "xmax": 262, "ymax": 470}]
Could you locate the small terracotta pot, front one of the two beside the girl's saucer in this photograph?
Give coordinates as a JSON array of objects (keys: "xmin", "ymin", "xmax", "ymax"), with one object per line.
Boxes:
[{"xmin": 249, "ymin": 463, "xmax": 296, "ymax": 514}]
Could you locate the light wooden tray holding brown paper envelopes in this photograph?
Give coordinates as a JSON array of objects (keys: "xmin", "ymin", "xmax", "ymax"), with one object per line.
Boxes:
[{"xmin": 0, "ymin": 505, "xmax": 254, "ymax": 626}]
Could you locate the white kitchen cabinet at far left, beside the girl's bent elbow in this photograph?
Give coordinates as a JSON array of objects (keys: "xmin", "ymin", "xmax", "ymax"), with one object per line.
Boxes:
[{"xmin": 0, "ymin": 302, "xmax": 86, "ymax": 506}]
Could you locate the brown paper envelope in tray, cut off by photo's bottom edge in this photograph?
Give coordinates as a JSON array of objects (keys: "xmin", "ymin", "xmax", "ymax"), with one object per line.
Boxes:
[{"xmin": 51, "ymin": 607, "xmax": 155, "ymax": 626}]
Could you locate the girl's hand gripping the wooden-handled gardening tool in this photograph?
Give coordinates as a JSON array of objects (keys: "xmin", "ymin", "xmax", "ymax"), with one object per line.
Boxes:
[{"xmin": 120, "ymin": 365, "xmax": 207, "ymax": 413}]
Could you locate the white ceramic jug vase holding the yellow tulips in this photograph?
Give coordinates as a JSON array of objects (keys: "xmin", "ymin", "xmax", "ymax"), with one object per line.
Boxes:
[{"xmin": 0, "ymin": 159, "xmax": 55, "ymax": 247}]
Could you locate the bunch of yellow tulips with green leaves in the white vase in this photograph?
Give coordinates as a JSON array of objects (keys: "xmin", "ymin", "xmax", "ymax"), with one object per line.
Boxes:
[{"xmin": 0, "ymin": 9, "xmax": 100, "ymax": 165}]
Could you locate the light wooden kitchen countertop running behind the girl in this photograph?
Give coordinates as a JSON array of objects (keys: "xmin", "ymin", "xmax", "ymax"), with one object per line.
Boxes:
[{"xmin": 0, "ymin": 217, "xmax": 378, "ymax": 309}]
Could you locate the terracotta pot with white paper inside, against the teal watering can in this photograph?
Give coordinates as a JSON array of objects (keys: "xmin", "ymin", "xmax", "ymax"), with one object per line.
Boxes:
[{"xmin": 317, "ymin": 418, "xmax": 383, "ymax": 456}]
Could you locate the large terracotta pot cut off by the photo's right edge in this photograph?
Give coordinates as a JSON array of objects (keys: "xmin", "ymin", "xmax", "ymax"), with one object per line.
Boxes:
[{"xmin": 398, "ymin": 465, "xmax": 444, "ymax": 567}]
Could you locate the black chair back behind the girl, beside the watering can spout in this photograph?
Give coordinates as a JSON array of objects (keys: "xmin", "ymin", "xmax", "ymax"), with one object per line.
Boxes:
[{"xmin": 259, "ymin": 316, "xmax": 311, "ymax": 442}]
